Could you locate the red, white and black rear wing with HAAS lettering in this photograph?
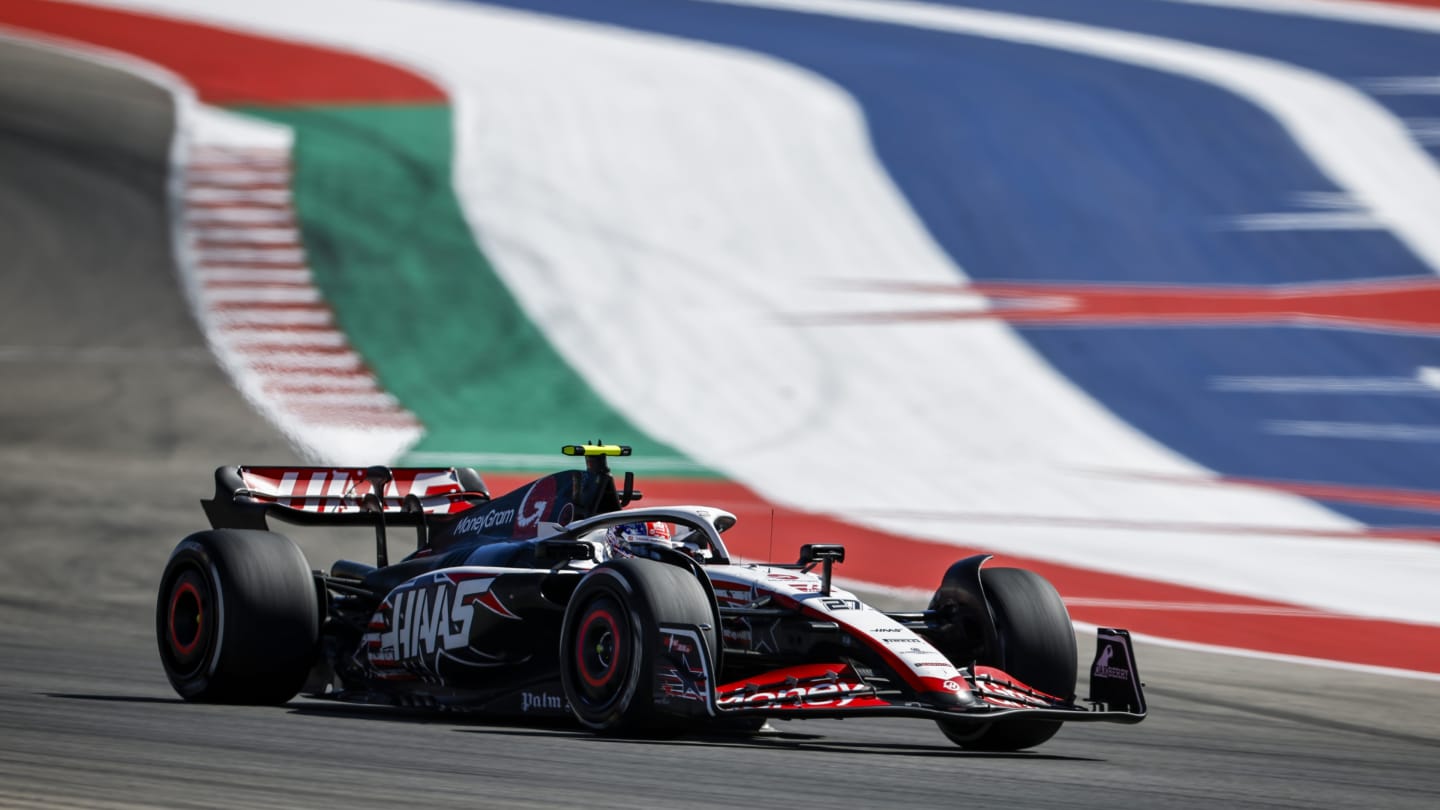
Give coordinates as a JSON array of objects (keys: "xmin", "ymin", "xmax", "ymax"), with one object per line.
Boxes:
[{"xmin": 200, "ymin": 467, "xmax": 490, "ymax": 530}]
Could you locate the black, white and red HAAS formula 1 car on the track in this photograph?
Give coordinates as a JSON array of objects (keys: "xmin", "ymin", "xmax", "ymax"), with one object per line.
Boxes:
[{"xmin": 156, "ymin": 445, "xmax": 1146, "ymax": 751}]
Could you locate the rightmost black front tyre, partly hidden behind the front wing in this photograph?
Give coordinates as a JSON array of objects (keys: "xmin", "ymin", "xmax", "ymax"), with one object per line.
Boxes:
[{"xmin": 940, "ymin": 568, "xmax": 1076, "ymax": 751}]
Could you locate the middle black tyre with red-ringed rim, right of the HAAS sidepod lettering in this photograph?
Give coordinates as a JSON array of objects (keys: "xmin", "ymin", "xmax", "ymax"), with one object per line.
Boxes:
[{"xmin": 560, "ymin": 559, "xmax": 719, "ymax": 734}]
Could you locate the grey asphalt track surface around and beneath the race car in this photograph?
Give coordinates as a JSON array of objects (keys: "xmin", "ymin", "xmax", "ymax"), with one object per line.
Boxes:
[{"xmin": 0, "ymin": 34, "xmax": 1440, "ymax": 810}]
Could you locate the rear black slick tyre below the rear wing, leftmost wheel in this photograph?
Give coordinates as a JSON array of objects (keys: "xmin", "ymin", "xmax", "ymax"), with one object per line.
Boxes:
[{"xmin": 156, "ymin": 529, "xmax": 320, "ymax": 705}]
